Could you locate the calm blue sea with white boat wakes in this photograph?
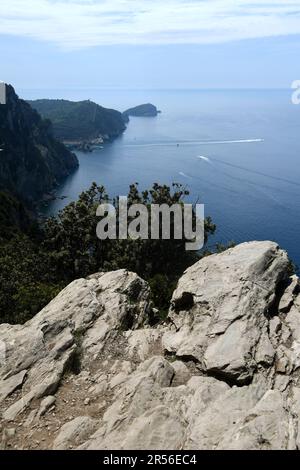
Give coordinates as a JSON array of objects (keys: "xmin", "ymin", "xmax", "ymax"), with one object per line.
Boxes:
[{"xmin": 23, "ymin": 90, "xmax": 300, "ymax": 265}]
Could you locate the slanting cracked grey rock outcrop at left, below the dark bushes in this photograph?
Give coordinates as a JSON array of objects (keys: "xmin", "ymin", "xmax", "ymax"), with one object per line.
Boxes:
[{"xmin": 0, "ymin": 270, "xmax": 150, "ymax": 420}]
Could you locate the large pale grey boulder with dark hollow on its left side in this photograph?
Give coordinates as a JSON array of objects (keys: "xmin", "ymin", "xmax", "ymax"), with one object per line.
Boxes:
[{"xmin": 163, "ymin": 242, "xmax": 289, "ymax": 385}]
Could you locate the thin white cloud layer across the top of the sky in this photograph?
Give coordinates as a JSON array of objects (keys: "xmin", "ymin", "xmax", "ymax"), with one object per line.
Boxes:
[{"xmin": 0, "ymin": 0, "xmax": 300, "ymax": 49}]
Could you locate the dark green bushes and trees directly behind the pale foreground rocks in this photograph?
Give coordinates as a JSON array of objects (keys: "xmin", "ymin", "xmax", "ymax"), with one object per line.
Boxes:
[{"xmin": 0, "ymin": 183, "xmax": 215, "ymax": 323}]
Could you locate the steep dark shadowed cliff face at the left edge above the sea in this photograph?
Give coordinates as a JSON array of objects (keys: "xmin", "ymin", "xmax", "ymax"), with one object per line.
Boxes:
[{"xmin": 0, "ymin": 86, "xmax": 78, "ymax": 200}]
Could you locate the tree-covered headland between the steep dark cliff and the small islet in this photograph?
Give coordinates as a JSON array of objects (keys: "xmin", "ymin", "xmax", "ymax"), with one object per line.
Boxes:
[{"xmin": 29, "ymin": 100, "xmax": 127, "ymax": 141}]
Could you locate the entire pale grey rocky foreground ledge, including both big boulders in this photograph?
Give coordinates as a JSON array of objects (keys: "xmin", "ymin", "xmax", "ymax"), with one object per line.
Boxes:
[{"xmin": 0, "ymin": 242, "xmax": 300, "ymax": 449}]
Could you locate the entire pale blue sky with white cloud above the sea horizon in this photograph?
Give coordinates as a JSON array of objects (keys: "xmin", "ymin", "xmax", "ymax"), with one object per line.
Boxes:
[{"xmin": 0, "ymin": 0, "xmax": 300, "ymax": 90}]
